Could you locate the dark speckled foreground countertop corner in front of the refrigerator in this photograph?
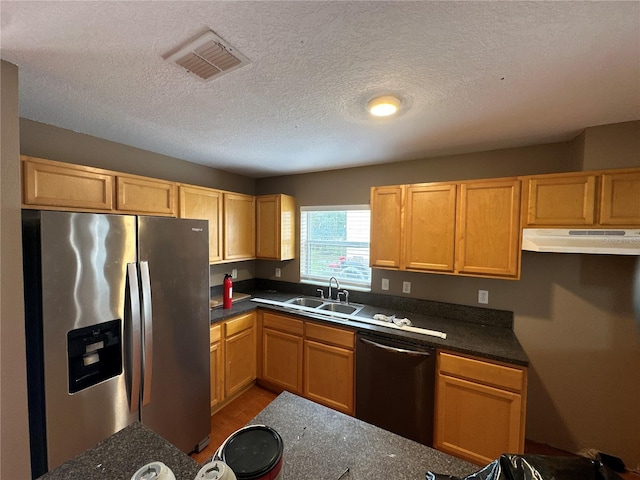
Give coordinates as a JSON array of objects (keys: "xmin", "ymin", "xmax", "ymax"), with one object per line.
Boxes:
[{"xmin": 40, "ymin": 422, "xmax": 201, "ymax": 480}]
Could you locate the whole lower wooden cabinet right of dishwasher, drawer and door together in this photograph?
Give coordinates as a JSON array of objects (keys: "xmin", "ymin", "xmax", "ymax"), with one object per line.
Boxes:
[{"xmin": 434, "ymin": 352, "xmax": 527, "ymax": 465}]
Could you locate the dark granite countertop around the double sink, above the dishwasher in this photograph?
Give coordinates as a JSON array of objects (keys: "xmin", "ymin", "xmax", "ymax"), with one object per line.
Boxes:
[{"xmin": 210, "ymin": 290, "xmax": 529, "ymax": 366}]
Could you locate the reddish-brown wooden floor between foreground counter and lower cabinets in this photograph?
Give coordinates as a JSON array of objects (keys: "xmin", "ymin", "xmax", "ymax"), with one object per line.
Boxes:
[{"xmin": 191, "ymin": 385, "xmax": 640, "ymax": 480}]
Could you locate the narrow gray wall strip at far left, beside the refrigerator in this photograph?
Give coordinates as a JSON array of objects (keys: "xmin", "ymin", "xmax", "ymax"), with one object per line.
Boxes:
[{"xmin": 0, "ymin": 61, "xmax": 31, "ymax": 479}]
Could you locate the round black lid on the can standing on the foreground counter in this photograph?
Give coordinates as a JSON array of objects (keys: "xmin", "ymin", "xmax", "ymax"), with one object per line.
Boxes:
[{"xmin": 220, "ymin": 425, "xmax": 283, "ymax": 480}]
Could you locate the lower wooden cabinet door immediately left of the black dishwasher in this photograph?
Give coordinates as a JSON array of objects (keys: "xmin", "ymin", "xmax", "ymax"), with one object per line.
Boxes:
[{"xmin": 303, "ymin": 340, "xmax": 354, "ymax": 415}]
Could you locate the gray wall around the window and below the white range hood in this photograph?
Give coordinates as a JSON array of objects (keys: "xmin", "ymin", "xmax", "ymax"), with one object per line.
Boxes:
[{"xmin": 256, "ymin": 122, "xmax": 640, "ymax": 468}]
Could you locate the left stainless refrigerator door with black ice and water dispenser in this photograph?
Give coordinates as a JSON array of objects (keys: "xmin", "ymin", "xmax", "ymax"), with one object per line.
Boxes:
[{"xmin": 23, "ymin": 211, "xmax": 138, "ymax": 474}]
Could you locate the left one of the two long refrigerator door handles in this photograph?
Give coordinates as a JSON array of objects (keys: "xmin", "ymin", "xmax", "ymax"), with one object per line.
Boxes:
[{"xmin": 125, "ymin": 263, "xmax": 142, "ymax": 413}]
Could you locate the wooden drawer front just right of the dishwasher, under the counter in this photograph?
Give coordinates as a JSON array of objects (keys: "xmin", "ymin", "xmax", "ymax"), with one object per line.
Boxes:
[{"xmin": 439, "ymin": 352, "xmax": 524, "ymax": 392}]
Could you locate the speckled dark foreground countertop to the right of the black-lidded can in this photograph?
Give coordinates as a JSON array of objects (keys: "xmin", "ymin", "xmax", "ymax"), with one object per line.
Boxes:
[{"xmin": 249, "ymin": 392, "xmax": 479, "ymax": 480}]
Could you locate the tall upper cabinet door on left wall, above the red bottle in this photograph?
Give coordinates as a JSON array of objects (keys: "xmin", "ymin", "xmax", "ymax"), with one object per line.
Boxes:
[{"xmin": 223, "ymin": 193, "xmax": 256, "ymax": 260}]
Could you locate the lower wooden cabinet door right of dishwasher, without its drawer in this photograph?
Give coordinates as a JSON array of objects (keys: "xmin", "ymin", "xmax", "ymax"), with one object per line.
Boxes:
[{"xmin": 434, "ymin": 375, "xmax": 522, "ymax": 465}]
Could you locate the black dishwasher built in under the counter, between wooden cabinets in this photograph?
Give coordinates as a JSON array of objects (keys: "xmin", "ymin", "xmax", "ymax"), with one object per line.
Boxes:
[{"xmin": 356, "ymin": 333, "xmax": 436, "ymax": 446}]
